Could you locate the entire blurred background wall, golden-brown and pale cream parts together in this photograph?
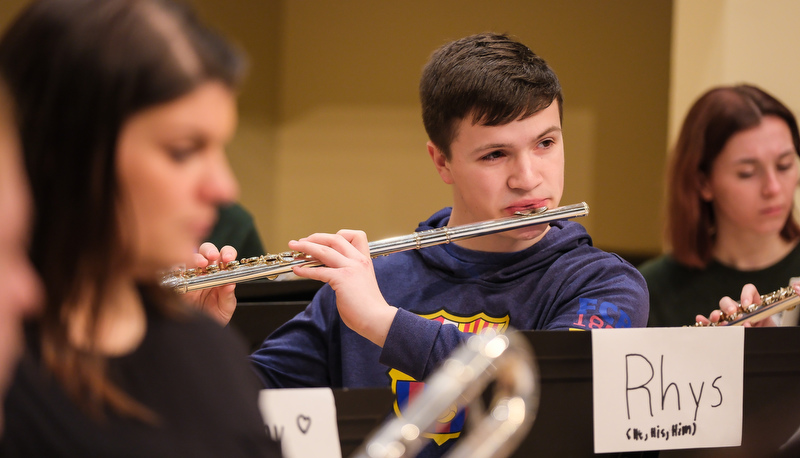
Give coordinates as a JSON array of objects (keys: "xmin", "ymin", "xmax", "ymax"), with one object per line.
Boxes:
[{"xmin": 6, "ymin": 0, "xmax": 800, "ymax": 263}]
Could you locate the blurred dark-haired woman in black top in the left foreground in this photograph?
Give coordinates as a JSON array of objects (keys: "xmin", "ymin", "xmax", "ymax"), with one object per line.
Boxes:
[{"xmin": 0, "ymin": 0, "xmax": 279, "ymax": 457}]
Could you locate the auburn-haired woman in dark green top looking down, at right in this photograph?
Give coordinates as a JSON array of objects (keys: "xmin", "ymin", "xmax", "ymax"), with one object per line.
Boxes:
[{"xmin": 640, "ymin": 85, "xmax": 800, "ymax": 326}]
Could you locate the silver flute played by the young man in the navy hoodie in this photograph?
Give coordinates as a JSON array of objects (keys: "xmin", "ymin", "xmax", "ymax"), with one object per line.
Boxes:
[{"xmin": 161, "ymin": 202, "xmax": 589, "ymax": 293}]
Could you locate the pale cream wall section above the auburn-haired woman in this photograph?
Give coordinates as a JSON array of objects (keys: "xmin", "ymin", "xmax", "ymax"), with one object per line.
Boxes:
[{"xmin": 669, "ymin": 0, "xmax": 800, "ymax": 144}]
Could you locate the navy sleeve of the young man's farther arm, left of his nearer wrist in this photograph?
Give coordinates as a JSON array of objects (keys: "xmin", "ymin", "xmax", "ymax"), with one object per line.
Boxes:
[{"xmin": 250, "ymin": 285, "xmax": 342, "ymax": 388}]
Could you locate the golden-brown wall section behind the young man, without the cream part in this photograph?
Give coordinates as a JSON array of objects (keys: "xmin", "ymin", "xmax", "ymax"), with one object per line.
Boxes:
[{"xmin": 231, "ymin": 0, "xmax": 671, "ymax": 253}]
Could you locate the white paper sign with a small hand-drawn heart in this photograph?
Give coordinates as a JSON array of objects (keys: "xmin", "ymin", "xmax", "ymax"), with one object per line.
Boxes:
[{"xmin": 258, "ymin": 388, "xmax": 342, "ymax": 458}]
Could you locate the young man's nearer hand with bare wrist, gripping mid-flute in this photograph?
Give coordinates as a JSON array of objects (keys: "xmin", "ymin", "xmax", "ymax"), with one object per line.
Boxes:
[{"xmin": 289, "ymin": 230, "xmax": 397, "ymax": 347}]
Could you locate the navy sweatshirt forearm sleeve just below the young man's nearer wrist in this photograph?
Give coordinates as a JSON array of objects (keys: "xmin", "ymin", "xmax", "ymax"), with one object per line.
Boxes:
[{"xmin": 380, "ymin": 309, "xmax": 470, "ymax": 380}]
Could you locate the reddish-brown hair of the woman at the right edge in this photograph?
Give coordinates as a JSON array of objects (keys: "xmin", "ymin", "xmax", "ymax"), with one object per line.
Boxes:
[{"xmin": 666, "ymin": 85, "xmax": 800, "ymax": 268}]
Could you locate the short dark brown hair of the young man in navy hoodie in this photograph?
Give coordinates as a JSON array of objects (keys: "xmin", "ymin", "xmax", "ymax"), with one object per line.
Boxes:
[{"xmin": 419, "ymin": 33, "xmax": 563, "ymax": 158}]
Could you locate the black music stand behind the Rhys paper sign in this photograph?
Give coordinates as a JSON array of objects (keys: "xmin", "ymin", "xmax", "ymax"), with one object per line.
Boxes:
[{"xmin": 512, "ymin": 327, "xmax": 800, "ymax": 458}]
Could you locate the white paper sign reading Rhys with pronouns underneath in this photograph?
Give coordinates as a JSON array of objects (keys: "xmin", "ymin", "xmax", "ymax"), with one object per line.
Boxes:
[{"xmin": 592, "ymin": 326, "xmax": 744, "ymax": 453}]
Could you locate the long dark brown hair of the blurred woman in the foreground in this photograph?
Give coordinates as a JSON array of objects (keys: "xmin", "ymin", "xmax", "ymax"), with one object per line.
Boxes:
[{"xmin": 0, "ymin": 0, "xmax": 244, "ymax": 417}]
